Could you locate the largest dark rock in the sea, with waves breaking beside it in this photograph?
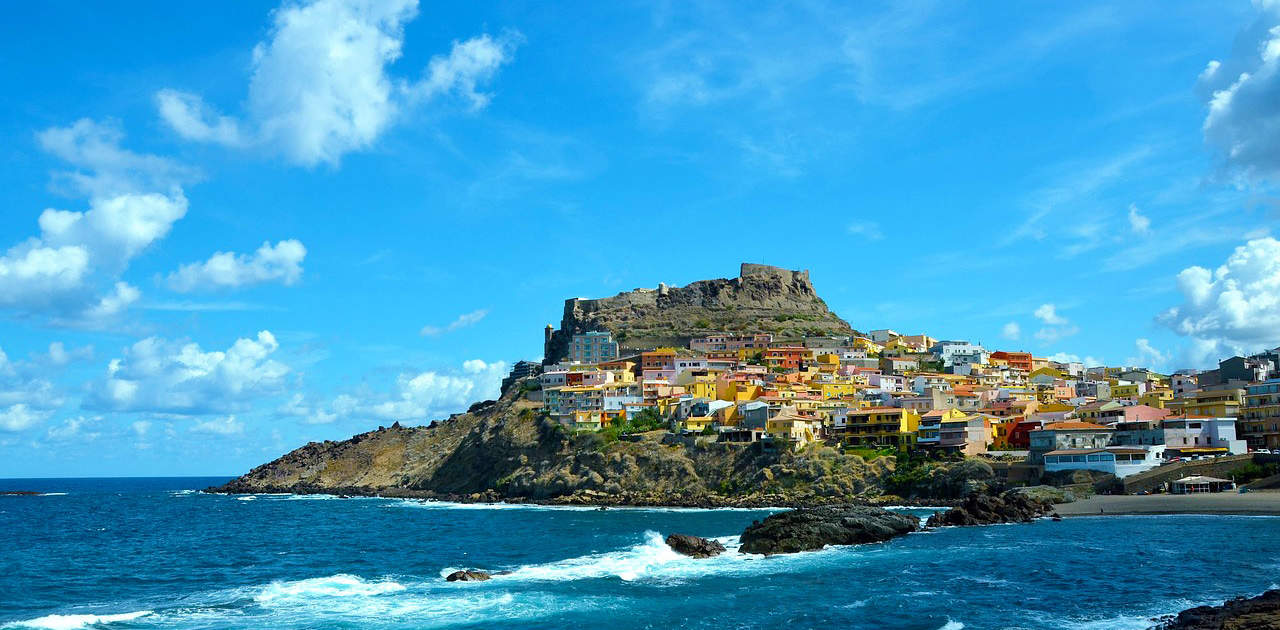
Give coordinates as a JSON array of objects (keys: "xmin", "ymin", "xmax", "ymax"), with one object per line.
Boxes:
[{"xmin": 740, "ymin": 505, "xmax": 920, "ymax": 554}]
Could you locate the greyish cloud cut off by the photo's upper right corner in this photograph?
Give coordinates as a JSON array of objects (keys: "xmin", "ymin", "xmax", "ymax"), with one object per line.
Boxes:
[{"xmin": 1199, "ymin": 1, "xmax": 1280, "ymax": 178}]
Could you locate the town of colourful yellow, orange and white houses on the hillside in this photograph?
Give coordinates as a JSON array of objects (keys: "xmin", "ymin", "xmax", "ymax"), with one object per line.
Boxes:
[{"xmin": 503, "ymin": 327, "xmax": 1280, "ymax": 492}]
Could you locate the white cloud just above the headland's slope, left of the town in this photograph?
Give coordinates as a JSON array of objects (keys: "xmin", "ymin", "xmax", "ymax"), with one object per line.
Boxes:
[{"xmin": 367, "ymin": 359, "xmax": 507, "ymax": 420}]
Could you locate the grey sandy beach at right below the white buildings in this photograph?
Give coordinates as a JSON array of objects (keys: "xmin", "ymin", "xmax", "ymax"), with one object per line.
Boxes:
[{"xmin": 1056, "ymin": 490, "xmax": 1280, "ymax": 516}]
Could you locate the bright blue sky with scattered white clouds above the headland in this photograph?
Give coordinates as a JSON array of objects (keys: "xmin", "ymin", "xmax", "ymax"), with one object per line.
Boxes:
[{"xmin": 0, "ymin": 0, "xmax": 1280, "ymax": 478}]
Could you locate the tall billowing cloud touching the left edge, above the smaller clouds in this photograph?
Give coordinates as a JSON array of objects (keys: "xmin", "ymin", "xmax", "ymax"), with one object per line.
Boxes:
[{"xmin": 0, "ymin": 120, "xmax": 195, "ymax": 323}]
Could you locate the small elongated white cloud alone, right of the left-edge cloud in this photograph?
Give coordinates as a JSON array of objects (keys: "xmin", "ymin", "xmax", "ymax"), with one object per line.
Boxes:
[{"xmin": 168, "ymin": 239, "xmax": 307, "ymax": 293}]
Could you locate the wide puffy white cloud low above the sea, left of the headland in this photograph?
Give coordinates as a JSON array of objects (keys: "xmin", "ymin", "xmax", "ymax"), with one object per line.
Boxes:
[{"xmin": 83, "ymin": 330, "xmax": 289, "ymax": 415}]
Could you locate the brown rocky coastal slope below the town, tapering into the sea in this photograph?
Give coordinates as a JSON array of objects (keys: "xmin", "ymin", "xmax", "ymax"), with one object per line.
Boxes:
[{"xmin": 212, "ymin": 387, "xmax": 952, "ymax": 506}]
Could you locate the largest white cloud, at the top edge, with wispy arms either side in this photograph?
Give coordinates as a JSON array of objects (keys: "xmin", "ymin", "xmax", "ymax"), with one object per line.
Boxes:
[{"xmin": 156, "ymin": 0, "xmax": 521, "ymax": 165}]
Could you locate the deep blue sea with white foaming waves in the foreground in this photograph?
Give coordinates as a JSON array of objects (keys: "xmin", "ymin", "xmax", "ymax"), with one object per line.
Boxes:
[{"xmin": 0, "ymin": 478, "xmax": 1280, "ymax": 630}]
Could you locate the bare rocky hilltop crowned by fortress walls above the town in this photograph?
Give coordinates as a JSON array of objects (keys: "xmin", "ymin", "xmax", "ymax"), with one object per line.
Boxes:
[{"xmin": 545, "ymin": 263, "xmax": 854, "ymax": 364}]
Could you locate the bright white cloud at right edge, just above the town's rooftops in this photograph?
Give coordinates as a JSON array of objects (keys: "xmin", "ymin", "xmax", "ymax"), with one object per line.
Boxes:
[{"xmin": 1157, "ymin": 237, "xmax": 1280, "ymax": 359}]
